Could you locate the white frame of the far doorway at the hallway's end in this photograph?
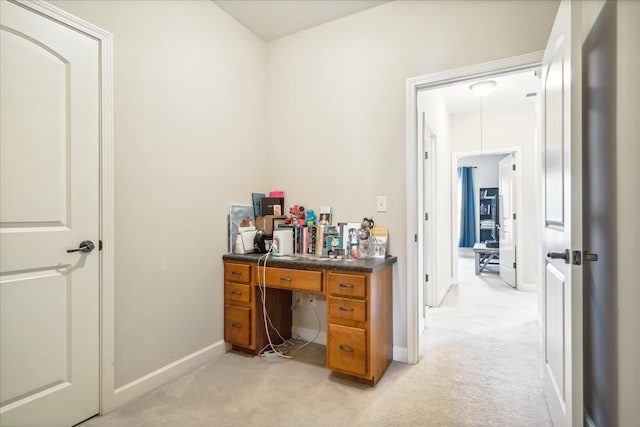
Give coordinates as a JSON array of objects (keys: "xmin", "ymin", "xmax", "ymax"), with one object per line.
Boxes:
[{"xmin": 451, "ymin": 148, "xmax": 524, "ymax": 291}]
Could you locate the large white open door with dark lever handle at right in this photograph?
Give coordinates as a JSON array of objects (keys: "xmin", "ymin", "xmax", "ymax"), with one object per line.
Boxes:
[{"xmin": 542, "ymin": 1, "xmax": 583, "ymax": 427}]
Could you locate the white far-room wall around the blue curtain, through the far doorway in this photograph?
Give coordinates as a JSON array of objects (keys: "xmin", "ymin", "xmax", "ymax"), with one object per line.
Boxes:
[{"xmin": 452, "ymin": 154, "xmax": 505, "ymax": 246}]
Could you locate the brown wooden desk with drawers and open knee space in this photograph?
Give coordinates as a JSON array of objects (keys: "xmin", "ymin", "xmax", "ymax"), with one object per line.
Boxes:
[{"xmin": 223, "ymin": 254, "xmax": 397, "ymax": 384}]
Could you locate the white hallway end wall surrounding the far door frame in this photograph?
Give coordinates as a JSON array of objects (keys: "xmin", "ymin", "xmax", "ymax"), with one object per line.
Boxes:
[{"xmin": 451, "ymin": 104, "xmax": 539, "ymax": 288}]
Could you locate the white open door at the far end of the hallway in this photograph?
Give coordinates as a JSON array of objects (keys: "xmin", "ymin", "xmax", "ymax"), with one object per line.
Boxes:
[{"xmin": 498, "ymin": 154, "xmax": 516, "ymax": 288}]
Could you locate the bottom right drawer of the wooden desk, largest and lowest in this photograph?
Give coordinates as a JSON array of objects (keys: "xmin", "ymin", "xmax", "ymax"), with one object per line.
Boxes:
[{"xmin": 327, "ymin": 323, "xmax": 367, "ymax": 376}]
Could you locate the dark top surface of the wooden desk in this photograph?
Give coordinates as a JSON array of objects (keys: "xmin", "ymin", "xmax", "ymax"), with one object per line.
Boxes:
[{"xmin": 222, "ymin": 254, "xmax": 398, "ymax": 273}]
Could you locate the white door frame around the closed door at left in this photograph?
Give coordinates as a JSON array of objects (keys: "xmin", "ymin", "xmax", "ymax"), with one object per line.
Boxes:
[{"xmin": 15, "ymin": 0, "xmax": 115, "ymax": 414}]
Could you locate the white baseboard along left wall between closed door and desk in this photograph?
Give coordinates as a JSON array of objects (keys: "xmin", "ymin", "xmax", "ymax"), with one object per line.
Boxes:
[{"xmin": 111, "ymin": 341, "xmax": 227, "ymax": 410}]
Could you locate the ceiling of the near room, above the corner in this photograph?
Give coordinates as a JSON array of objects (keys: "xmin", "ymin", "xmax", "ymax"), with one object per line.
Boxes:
[{"xmin": 213, "ymin": 0, "xmax": 388, "ymax": 42}]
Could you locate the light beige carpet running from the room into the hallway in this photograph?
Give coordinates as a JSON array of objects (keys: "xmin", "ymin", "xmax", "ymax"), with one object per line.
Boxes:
[{"xmin": 82, "ymin": 259, "xmax": 551, "ymax": 427}]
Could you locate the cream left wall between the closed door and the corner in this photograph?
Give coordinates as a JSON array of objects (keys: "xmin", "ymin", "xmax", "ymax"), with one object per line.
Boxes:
[{"xmin": 54, "ymin": 1, "xmax": 266, "ymax": 392}]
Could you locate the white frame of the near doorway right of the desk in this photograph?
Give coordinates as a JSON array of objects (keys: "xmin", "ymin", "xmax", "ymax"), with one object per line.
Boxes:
[{"xmin": 405, "ymin": 51, "xmax": 544, "ymax": 363}]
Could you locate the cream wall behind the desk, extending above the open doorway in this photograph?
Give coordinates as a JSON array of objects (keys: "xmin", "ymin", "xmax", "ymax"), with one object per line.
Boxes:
[{"xmin": 266, "ymin": 1, "xmax": 558, "ymax": 348}]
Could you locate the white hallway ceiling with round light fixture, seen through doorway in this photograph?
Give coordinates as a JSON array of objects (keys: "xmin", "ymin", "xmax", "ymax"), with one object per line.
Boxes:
[{"xmin": 438, "ymin": 70, "xmax": 540, "ymax": 114}]
